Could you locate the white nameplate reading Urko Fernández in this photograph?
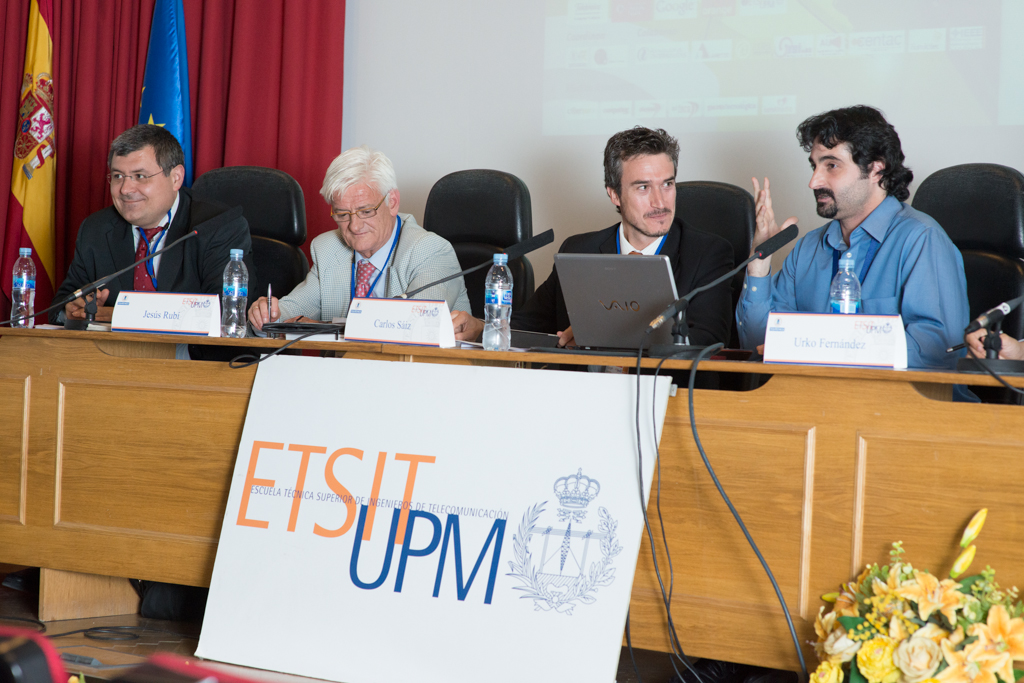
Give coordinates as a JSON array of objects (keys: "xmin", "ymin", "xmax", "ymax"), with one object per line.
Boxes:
[{"xmin": 765, "ymin": 312, "xmax": 906, "ymax": 370}]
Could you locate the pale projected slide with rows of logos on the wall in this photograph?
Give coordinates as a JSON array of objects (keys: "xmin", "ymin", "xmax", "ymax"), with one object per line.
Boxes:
[{"xmin": 544, "ymin": 0, "xmax": 1024, "ymax": 135}]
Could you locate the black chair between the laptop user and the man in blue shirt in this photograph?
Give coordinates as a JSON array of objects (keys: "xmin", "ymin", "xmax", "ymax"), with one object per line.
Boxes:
[{"xmin": 676, "ymin": 180, "xmax": 754, "ymax": 348}]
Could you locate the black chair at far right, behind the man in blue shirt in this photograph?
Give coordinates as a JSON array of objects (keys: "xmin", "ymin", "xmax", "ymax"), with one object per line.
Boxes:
[{"xmin": 913, "ymin": 164, "xmax": 1024, "ymax": 402}]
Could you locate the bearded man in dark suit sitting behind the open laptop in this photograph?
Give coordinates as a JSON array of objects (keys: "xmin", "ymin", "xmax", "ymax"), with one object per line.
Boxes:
[{"xmin": 453, "ymin": 126, "xmax": 732, "ymax": 346}]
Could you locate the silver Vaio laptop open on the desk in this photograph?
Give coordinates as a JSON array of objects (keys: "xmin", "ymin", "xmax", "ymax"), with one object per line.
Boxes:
[{"xmin": 555, "ymin": 254, "xmax": 679, "ymax": 349}]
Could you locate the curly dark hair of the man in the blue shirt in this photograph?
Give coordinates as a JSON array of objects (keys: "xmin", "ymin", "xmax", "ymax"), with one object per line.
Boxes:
[{"xmin": 797, "ymin": 104, "xmax": 913, "ymax": 202}]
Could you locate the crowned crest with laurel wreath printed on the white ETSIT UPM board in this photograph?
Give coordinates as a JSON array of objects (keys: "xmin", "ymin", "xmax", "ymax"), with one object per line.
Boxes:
[{"xmin": 508, "ymin": 469, "xmax": 623, "ymax": 615}]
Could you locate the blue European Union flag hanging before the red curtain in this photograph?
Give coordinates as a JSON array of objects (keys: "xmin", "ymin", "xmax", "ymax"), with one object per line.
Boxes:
[{"xmin": 138, "ymin": 0, "xmax": 193, "ymax": 186}]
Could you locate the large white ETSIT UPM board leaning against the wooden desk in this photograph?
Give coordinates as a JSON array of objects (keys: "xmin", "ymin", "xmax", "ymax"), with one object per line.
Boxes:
[{"xmin": 197, "ymin": 356, "xmax": 670, "ymax": 683}]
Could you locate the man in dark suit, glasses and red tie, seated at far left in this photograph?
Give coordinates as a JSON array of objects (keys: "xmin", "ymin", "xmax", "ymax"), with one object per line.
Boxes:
[{"xmin": 50, "ymin": 125, "xmax": 259, "ymax": 324}]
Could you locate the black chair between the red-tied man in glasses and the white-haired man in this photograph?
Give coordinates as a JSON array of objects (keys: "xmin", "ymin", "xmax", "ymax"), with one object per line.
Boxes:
[{"xmin": 193, "ymin": 166, "xmax": 309, "ymax": 300}]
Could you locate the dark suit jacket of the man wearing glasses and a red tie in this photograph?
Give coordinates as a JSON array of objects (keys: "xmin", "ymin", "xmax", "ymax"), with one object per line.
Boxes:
[{"xmin": 50, "ymin": 187, "xmax": 260, "ymax": 323}]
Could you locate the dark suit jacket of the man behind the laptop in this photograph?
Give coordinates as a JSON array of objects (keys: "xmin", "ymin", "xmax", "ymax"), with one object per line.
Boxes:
[{"xmin": 512, "ymin": 216, "xmax": 732, "ymax": 346}]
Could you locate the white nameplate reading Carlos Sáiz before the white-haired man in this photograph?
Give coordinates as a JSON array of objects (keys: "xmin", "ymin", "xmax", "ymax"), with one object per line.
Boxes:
[{"xmin": 345, "ymin": 299, "xmax": 455, "ymax": 348}]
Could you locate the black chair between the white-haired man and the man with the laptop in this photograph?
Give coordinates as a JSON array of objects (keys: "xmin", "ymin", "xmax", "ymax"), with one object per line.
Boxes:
[{"xmin": 423, "ymin": 169, "xmax": 534, "ymax": 317}]
